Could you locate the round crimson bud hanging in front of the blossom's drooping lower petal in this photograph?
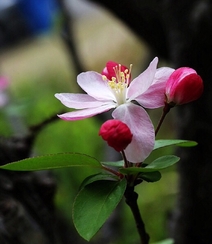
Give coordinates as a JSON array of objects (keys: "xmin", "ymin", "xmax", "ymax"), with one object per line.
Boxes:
[{"xmin": 99, "ymin": 119, "xmax": 133, "ymax": 152}]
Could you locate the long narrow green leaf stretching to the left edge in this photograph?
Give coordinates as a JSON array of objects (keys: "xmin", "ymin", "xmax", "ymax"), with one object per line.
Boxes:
[{"xmin": 0, "ymin": 153, "xmax": 102, "ymax": 171}]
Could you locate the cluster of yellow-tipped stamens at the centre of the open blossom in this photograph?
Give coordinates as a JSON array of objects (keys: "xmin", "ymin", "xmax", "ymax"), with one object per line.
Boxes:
[{"xmin": 102, "ymin": 64, "xmax": 132, "ymax": 105}]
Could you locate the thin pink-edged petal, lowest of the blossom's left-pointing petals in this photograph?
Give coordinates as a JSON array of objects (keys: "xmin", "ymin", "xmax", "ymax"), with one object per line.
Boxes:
[{"xmin": 58, "ymin": 103, "xmax": 116, "ymax": 121}]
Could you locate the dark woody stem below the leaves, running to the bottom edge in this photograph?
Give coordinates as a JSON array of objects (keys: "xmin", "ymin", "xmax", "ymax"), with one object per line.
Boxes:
[{"xmin": 124, "ymin": 185, "xmax": 149, "ymax": 244}]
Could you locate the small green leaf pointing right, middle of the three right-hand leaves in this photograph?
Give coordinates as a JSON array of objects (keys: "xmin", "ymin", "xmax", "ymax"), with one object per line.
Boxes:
[{"xmin": 120, "ymin": 155, "xmax": 180, "ymax": 174}]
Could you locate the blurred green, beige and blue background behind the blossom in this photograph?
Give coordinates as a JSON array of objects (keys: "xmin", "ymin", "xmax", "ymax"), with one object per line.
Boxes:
[{"xmin": 0, "ymin": 0, "xmax": 177, "ymax": 244}]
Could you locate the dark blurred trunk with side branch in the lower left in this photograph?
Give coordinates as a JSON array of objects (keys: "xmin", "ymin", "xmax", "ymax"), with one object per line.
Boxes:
[{"xmin": 0, "ymin": 115, "xmax": 85, "ymax": 244}]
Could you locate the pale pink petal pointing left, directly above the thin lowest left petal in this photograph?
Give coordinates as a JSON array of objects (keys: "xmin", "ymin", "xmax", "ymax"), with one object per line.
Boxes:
[{"xmin": 55, "ymin": 93, "xmax": 108, "ymax": 109}]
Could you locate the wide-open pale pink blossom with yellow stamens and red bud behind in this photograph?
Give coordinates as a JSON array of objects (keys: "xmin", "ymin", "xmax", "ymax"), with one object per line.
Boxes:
[{"xmin": 55, "ymin": 58, "xmax": 174, "ymax": 163}]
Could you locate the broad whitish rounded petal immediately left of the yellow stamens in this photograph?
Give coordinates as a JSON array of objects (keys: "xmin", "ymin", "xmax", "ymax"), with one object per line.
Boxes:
[{"xmin": 77, "ymin": 71, "xmax": 116, "ymax": 101}]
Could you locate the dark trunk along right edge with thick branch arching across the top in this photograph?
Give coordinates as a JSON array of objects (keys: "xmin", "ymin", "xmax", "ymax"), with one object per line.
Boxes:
[{"xmin": 89, "ymin": 0, "xmax": 212, "ymax": 244}]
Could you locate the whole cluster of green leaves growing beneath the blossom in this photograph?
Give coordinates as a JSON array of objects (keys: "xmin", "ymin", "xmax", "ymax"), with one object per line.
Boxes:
[{"xmin": 0, "ymin": 136, "xmax": 196, "ymax": 240}]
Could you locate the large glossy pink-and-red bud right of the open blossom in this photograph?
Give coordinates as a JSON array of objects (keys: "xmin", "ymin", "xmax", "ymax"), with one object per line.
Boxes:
[{"xmin": 165, "ymin": 67, "xmax": 203, "ymax": 106}]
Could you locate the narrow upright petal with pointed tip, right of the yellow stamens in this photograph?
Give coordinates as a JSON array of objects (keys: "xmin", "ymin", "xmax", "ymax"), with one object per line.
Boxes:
[{"xmin": 127, "ymin": 57, "xmax": 158, "ymax": 101}]
